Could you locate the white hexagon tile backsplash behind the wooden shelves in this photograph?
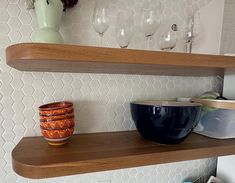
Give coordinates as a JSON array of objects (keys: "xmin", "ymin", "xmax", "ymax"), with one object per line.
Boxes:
[{"xmin": 0, "ymin": 0, "xmax": 221, "ymax": 183}]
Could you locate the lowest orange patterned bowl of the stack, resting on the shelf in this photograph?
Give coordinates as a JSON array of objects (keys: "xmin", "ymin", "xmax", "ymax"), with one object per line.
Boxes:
[{"xmin": 41, "ymin": 128, "xmax": 74, "ymax": 146}]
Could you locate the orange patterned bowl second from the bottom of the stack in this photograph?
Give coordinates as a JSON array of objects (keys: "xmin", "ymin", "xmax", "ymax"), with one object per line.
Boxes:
[{"xmin": 40, "ymin": 116, "xmax": 74, "ymax": 130}]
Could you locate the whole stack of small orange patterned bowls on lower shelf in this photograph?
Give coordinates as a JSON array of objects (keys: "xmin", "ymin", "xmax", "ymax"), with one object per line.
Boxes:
[{"xmin": 39, "ymin": 101, "xmax": 74, "ymax": 146}]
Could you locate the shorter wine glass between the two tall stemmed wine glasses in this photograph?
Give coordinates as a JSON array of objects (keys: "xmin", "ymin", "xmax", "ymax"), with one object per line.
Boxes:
[{"xmin": 116, "ymin": 10, "xmax": 134, "ymax": 48}]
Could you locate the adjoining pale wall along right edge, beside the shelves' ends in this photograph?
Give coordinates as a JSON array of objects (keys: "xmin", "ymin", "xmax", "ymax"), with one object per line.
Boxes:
[{"xmin": 217, "ymin": 0, "xmax": 235, "ymax": 183}]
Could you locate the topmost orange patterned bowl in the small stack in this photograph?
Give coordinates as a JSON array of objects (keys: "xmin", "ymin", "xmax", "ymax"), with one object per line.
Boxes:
[{"xmin": 39, "ymin": 101, "xmax": 73, "ymax": 116}]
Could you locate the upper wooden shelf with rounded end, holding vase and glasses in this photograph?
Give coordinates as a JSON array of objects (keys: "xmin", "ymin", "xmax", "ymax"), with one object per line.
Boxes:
[{"xmin": 6, "ymin": 43, "xmax": 235, "ymax": 76}]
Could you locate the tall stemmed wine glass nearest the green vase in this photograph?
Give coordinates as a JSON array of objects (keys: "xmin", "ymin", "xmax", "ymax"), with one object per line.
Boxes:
[{"xmin": 92, "ymin": 0, "xmax": 110, "ymax": 45}]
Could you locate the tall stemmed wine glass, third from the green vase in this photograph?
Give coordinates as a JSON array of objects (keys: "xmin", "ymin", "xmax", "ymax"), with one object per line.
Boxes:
[{"xmin": 142, "ymin": 2, "xmax": 162, "ymax": 48}]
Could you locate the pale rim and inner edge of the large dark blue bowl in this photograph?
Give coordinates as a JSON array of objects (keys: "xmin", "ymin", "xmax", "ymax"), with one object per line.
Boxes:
[{"xmin": 131, "ymin": 100, "xmax": 202, "ymax": 107}]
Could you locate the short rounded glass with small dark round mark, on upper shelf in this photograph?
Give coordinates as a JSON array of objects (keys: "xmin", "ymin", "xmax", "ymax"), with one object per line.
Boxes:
[{"xmin": 159, "ymin": 24, "xmax": 177, "ymax": 51}]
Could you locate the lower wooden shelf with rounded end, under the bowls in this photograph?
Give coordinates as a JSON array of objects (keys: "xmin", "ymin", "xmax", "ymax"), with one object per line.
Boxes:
[{"xmin": 12, "ymin": 131, "xmax": 235, "ymax": 179}]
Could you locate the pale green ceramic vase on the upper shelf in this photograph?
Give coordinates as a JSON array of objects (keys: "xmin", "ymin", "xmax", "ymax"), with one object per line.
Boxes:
[{"xmin": 33, "ymin": 0, "xmax": 64, "ymax": 43}]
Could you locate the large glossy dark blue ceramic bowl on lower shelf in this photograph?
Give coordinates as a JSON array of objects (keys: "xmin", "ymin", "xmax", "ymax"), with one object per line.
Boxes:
[{"xmin": 131, "ymin": 101, "xmax": 201, "ymax": 144}]
